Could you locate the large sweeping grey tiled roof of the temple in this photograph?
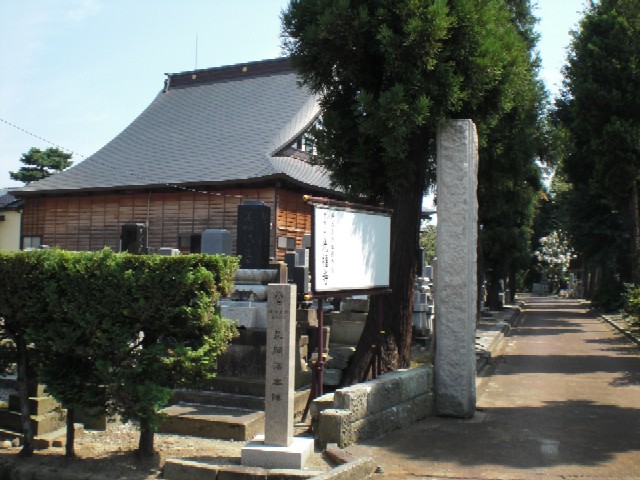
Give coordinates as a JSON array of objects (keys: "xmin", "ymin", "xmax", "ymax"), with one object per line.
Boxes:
[{"xmin": 12, "ymin": 59, "xmax": 333, "ymax": 195}]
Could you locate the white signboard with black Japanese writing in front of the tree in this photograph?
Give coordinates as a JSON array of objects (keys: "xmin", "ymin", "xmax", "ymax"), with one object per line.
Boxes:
[{"xmin": 312, "ymin": 204, "xmax": 391, "ymax": 293}]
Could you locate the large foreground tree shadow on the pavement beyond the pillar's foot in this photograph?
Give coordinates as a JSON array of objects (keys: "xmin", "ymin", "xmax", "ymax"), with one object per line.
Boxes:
[{"xmin": 362, "ymin": 401, "xmax": 640, "ymax": 469}]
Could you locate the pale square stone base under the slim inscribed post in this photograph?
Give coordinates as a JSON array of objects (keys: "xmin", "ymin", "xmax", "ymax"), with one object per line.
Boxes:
[{"xmin": 241, "ymin": 435, "xmax": 314, "ymax": 469}]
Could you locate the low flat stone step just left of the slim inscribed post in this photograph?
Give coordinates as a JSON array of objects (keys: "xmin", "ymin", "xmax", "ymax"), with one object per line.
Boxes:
[{"xmin": 158, "ymin": 403, "xmax": 264, "ymax": 441}]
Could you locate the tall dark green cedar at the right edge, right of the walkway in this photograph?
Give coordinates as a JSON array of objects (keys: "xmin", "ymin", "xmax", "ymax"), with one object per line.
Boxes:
[{"xmin": 556, "ymin": 0, "xmax": 640, "ymax": 284}]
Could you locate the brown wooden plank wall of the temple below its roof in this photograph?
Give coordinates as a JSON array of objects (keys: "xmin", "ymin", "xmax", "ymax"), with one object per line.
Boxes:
[{"xmin": 22, "ymin": 188, "xmax": 311, "ymax": 260}]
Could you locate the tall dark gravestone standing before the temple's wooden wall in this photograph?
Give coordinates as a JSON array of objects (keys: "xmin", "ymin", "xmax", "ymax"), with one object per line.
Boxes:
[{"xmin": 236, "ymin": 200, "xmax": 271, "ymax": 268}]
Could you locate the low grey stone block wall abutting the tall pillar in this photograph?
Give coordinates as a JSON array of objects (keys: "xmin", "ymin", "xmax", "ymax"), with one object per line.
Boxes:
[{"xmin": 310, "ymin": 366, "xmax": 434, "ymax": 448}]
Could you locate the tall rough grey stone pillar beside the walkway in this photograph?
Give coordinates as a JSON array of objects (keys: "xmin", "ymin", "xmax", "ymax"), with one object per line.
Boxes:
[{"xmin": 434, "ymin": 120, "xmax": 478, "ymax": 418}]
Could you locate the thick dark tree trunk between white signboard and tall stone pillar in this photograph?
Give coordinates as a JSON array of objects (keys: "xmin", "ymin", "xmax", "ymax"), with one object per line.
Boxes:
[{"xmin": 342, "ymin": 132, "xmax": 429, "ymax": 385}]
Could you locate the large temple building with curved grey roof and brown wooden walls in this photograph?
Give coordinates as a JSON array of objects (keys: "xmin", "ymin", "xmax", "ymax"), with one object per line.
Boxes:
[{"xmin": 12, "ymin": 58, "xmax": 341, "ymax": 259}]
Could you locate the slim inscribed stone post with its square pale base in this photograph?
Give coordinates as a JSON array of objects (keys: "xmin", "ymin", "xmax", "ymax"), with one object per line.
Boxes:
[{"xmin": 241, "ymin": 284, "xmax": 314, "ymax": 469}]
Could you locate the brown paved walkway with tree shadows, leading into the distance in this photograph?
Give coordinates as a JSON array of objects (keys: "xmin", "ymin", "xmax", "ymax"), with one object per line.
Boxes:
[{"xmin": 347, "ymin": 297, "xmax": 640, "ymax": 480}]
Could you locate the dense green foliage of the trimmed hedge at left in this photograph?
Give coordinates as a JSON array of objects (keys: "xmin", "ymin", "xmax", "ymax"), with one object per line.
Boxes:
[{"xmin": 0, "ymin": 249, "xmax": 238, "ymax": 456}]
